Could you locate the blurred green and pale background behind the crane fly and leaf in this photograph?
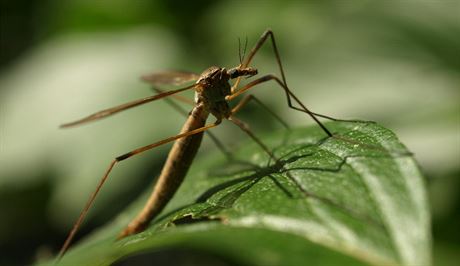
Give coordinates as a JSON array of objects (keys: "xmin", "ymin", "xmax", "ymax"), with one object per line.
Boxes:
[{"xmin": 0, "ymin": 0, "xmax": 460, "ymax": 265}]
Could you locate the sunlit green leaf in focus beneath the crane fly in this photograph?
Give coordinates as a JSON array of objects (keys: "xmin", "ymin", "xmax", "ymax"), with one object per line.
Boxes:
[{"xmin": 42, "ymin": 122, "xmax": 431, "ymax": 265}]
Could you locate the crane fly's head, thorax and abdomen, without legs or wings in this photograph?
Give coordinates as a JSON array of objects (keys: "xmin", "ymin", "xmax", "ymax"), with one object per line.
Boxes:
[{"xmin": 118, "ymin": 66, "xmax": 257, "ymax": 238}]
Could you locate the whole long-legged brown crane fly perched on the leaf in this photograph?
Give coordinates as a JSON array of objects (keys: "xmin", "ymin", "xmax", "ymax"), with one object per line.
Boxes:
[{"xmin": 58, "ymin": 29, "xmax": 333, "ymax": 258}]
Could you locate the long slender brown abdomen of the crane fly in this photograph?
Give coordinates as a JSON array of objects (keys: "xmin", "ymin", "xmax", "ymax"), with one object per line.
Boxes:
[{"xmin": 119, "ymin": 105, "xmax": 209, "ymax": 238}]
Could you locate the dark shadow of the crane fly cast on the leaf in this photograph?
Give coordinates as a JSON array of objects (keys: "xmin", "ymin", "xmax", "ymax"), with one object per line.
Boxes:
[{"xmin": 157, "ymin": 131, "xmax": 412, "ymax": 233}]
